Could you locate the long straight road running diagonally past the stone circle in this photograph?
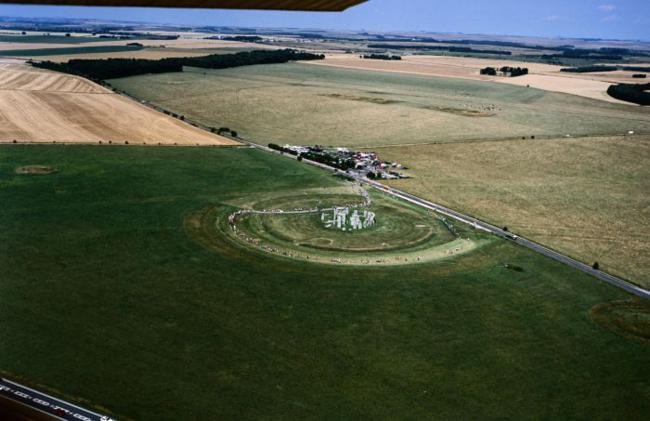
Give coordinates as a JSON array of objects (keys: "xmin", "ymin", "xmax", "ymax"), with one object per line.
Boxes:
[{"xmin": 236, "ymin": 139, "xmax": 650, "ymax": 299}]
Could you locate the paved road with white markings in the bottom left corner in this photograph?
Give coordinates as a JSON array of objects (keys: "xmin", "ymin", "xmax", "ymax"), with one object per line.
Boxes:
[{"xmin": 0, "ymin": 378, "xmax": 112, "ymax": 421}]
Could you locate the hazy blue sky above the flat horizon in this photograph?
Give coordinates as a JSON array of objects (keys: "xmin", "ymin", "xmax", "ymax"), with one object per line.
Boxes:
[{"xmin": 0, "ymin": 0, "xmax": 650, "ymax": 40}]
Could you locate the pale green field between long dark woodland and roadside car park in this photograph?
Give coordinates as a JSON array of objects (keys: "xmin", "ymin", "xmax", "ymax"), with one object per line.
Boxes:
[{"xmin": 111, "ymin": 63, "xmax": 650, "ymax": 147}]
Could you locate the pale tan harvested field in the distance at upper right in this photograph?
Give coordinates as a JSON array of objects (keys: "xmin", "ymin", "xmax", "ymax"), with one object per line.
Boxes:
[{"xmin": 308, "ymin": 54, "xmax": 631, "ymax": 104}]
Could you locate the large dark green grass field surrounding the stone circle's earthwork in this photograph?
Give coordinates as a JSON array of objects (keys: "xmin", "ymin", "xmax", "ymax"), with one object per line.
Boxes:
[{"xmin": 0, "ymin": 145, "xmax": 650, "ymax": 420}]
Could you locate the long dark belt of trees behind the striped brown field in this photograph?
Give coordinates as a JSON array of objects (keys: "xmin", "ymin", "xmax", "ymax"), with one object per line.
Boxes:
[{"xmin": 31, "ymin": 49, "xmax": 325, "ymax": 81}]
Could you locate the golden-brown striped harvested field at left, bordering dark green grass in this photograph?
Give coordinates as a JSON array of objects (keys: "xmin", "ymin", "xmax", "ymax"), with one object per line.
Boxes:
[{"xmin": 0, "ymin": 61, "xmax": 236, "ymax": 145}]
